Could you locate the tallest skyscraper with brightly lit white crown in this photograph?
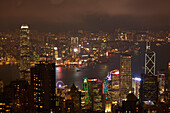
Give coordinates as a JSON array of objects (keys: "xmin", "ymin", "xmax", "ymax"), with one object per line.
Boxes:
[{"xmin": 19, "ymin": 25, "xmax": 31, "ymax": 84}]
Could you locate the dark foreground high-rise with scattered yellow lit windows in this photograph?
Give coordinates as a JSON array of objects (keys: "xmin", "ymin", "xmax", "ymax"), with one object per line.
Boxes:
[{"xmin": 31, "ymin": 63, "xmax": 56, "ymax": 113}]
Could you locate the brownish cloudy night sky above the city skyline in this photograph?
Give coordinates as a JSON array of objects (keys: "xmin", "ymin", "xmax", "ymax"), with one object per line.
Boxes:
[{"xmin": 0, "ymin": 0, "xmax": 170, "ymax": 32}]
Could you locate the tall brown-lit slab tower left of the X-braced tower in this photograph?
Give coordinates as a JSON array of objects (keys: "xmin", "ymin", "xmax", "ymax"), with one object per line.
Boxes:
[{"xmin": 120, "ymin": 54, "xmax": 132, "ymax": 102}]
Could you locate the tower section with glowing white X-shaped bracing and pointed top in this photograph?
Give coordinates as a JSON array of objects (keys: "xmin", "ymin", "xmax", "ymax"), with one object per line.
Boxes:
[{"xmin": 145, "ymin": 42, "xmax": 156, "ymax": 75}]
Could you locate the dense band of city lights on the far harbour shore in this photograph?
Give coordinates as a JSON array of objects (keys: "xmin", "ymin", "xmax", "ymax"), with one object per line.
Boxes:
[{"xmin": 0, "ymin": 25, "xmax": 170, "ymax": 65}]
